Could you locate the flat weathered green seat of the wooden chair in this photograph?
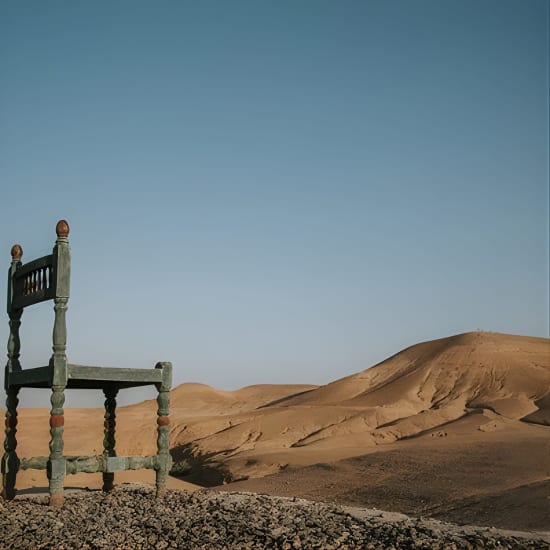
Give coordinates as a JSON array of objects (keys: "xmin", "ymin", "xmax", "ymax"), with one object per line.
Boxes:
[{"xmin": 9, "ymin": 363, "xmax": 162, "ymax": 390}]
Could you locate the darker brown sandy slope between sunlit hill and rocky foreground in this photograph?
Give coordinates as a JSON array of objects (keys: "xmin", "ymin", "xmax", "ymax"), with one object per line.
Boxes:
[{"xmin": 215, "ymin": 430, "xmax": 550, "ymax": 532}]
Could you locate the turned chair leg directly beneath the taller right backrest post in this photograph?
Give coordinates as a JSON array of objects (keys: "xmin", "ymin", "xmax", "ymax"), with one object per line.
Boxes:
[{"xmin": 48, "ymin": 386, "xmax": 65, "ymax": 506}]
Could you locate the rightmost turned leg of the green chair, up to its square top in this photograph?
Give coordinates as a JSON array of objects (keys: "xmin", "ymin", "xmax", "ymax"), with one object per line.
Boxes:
[{"xmin": 155, "ymin": 363, "xmax": 172, "ymax": 497}]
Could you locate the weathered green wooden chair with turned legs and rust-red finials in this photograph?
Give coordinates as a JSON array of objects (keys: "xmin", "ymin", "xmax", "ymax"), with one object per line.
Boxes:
[{"xmin": 1, "ymin": 220, "xmax": 172, "ymax": 506}]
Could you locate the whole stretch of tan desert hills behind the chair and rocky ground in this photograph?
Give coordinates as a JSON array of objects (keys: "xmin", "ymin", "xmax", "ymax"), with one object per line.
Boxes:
[{"xmin": 2, "ymin": 332, "xmax": 550, "ymax": 541}]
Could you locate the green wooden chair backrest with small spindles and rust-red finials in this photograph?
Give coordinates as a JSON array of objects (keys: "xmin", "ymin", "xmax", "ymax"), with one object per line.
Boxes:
[{"xmin": 7, "ymin": 220, "xmax": 71, "ymax": 371}]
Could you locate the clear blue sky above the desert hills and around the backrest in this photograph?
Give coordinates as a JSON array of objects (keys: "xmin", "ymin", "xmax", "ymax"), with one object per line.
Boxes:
[{"xmin": 0, "ymin": 0, "xmax": 549, "ymax": 404}]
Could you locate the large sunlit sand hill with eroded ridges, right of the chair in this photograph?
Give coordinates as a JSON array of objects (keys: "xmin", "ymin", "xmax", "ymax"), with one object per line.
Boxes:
[{"xmin": 169, "ymin": 332, "xmax": 550, "ymax": 479}]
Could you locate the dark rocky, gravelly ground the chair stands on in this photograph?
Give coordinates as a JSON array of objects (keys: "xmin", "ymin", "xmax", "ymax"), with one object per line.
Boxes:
[{"xmin": 0, "ymin": 485, "xmax": 550, "ymax": 550}]
